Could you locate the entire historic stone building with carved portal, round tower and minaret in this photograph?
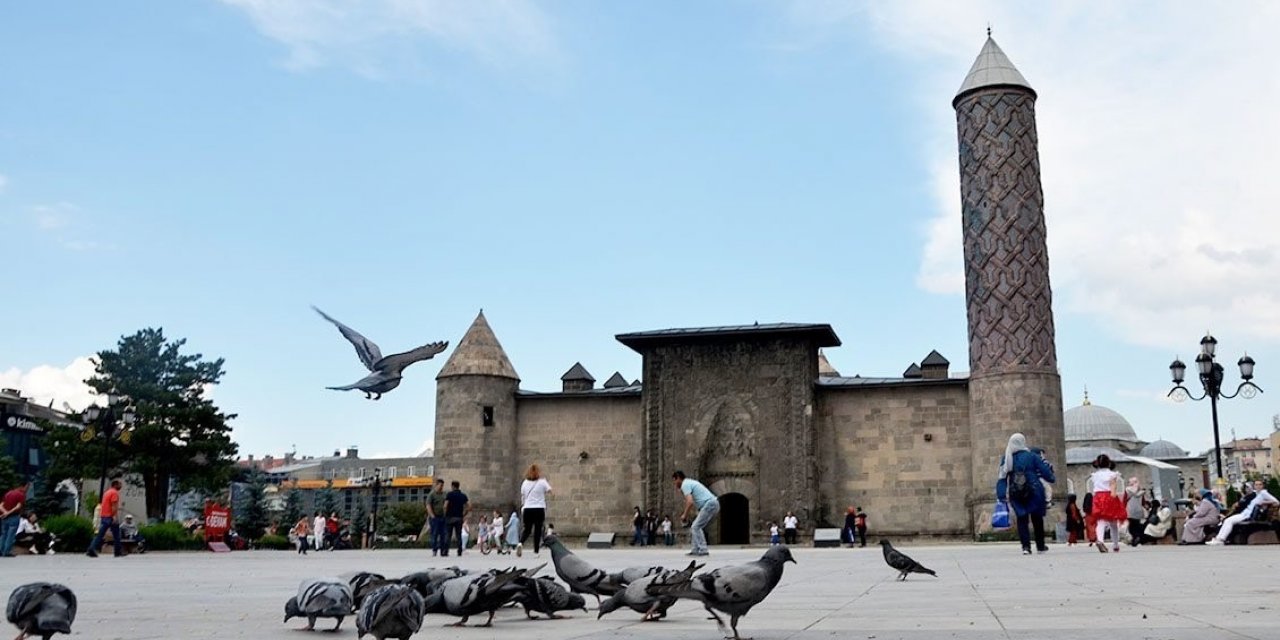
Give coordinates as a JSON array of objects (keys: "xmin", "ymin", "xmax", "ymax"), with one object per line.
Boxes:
[{"xmin": 435, "ymin": 38, "xmax": 1065, "ymax": 543}]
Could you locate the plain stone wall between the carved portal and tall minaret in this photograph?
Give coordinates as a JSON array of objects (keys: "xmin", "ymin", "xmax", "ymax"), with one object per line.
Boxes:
[{"xmin": 817, "ymin": 381, "xmax": 972, "ymax": 536}]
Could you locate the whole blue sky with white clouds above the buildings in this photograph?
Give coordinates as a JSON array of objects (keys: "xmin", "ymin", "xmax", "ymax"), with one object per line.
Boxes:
[{"xmin": 0, "ymin": 0, "xmax": 1280, "ymax": 457}]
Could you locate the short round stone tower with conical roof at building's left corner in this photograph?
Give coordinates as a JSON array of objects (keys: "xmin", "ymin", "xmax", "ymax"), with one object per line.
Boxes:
[{"xmin": 435, "ymin": 311, "xmax": 521, "ymax": 513}]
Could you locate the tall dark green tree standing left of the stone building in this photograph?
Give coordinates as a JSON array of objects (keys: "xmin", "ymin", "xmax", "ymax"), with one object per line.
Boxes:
[{"xmin": 86, "ymin": 329, "xmax": 237, "ymax": 520}]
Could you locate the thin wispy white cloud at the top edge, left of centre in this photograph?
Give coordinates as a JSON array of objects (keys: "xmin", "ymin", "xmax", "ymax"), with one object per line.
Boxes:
[{"xmin": 221, "ymin": 0, "xmax": 556, "ymax": 77}]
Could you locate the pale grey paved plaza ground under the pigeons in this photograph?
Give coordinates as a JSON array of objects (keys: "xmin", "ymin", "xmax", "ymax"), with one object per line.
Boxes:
[{"xmin": 0, "ymin": 544, "xmax": 1280, "ymax": 640}]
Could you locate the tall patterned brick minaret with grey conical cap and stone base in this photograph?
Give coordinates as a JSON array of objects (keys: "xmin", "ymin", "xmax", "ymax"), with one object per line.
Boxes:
[{"xmin": 951, "ymin": 33, "xmax": 1066, "ymax": 531}]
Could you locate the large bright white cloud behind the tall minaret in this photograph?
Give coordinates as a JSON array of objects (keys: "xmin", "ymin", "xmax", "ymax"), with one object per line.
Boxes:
[{"xmin": 791, "ymin": 0, "xmax": 1280, "ymax": 347}]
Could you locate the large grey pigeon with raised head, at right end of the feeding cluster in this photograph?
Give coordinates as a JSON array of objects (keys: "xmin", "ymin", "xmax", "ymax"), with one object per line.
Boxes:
[{"xmin": 645, "ymin": 544, "xmax": 795, "ymax": 640}]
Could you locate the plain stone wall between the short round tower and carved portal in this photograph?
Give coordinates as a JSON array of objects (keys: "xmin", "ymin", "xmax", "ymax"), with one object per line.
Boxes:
[{"xmin": 507, "ymin": 394, "xmax": 644, "ymax": 536}]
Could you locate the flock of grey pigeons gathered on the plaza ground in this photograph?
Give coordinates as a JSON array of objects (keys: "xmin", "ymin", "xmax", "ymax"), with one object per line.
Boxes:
[{"xmin": 5, "ymin": 535, "xmax": 937, "ymax": 640}]
